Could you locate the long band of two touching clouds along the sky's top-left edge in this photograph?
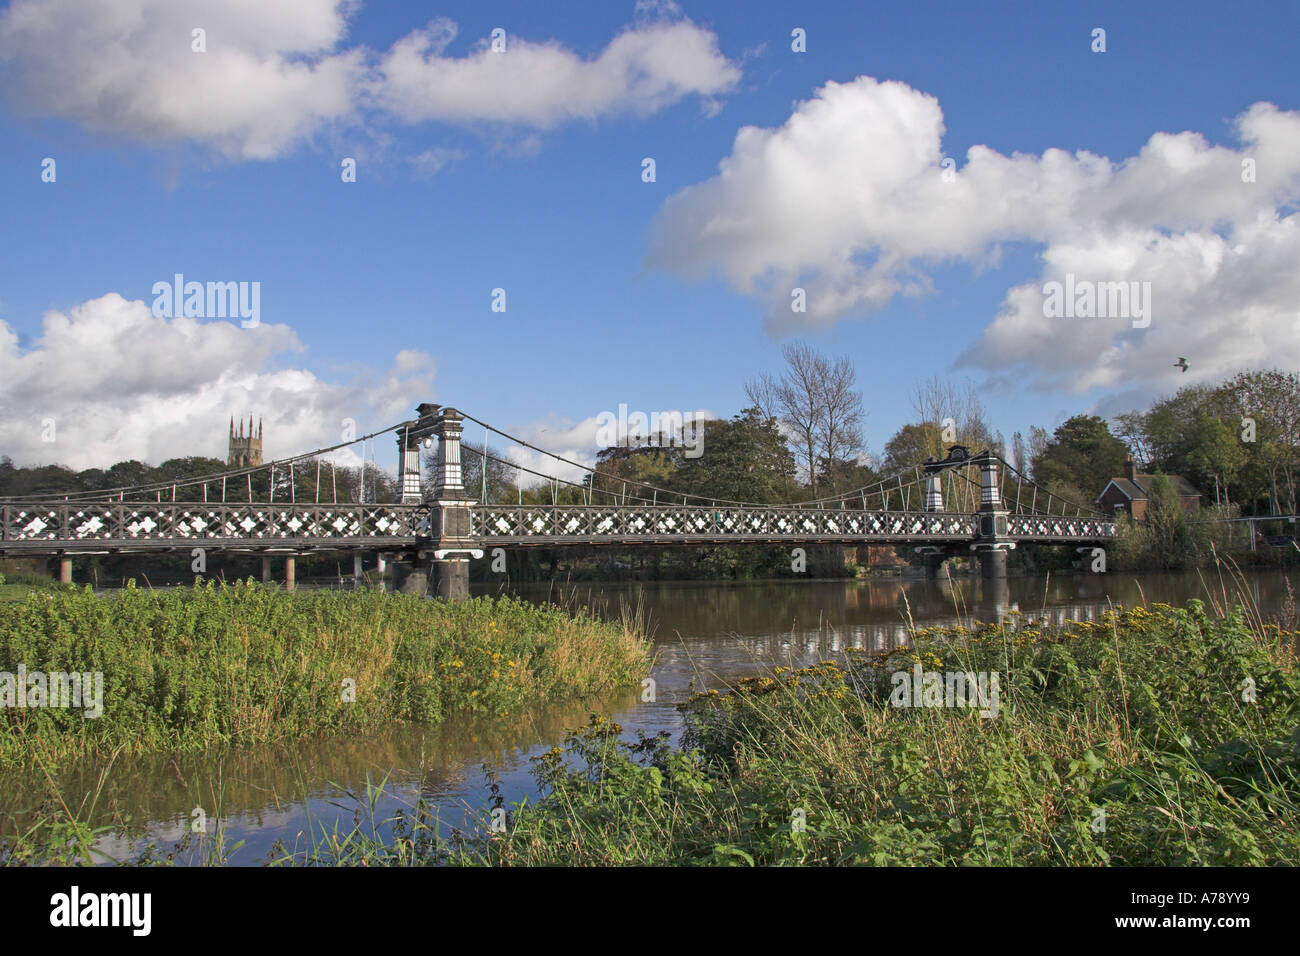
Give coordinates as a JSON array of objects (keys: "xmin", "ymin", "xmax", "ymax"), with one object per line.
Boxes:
[{"xmin": 0, "ymin": 0, "xmax": 740, "ymax": 160}]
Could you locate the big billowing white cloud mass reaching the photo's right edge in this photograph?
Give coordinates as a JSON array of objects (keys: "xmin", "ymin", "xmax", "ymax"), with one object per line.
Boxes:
[{"xmin": 647, "ymin": 77, "xmax": 1300, "ymax": 392}]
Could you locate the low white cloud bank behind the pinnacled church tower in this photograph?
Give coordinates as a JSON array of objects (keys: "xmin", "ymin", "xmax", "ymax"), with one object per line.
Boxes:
[{"xmin": 0, "ymin": 293, "xmax": 433, "ymax": 470}]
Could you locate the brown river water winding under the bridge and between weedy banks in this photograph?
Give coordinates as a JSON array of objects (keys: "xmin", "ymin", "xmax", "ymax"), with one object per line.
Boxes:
[{"xmin": 0, "ymin": 571, "xmax": 1300, "ymax": 865}]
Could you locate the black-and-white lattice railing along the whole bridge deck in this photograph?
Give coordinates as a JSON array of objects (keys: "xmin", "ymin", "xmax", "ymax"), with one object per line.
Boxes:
[{"xmin": 0, "ymin": 502, "xmax": 1115, "ymax": 553}]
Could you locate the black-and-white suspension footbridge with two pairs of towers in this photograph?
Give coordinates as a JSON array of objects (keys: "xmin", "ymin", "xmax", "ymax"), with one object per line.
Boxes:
[{"xmin": 0, "ymin": 403, "xmax": 1115, "ymax": 600}]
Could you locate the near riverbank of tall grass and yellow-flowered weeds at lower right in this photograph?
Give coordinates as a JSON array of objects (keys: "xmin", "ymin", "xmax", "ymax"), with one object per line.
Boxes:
[{"xmin": 295, "ymin": 601, "xmax": 1300, "ymax": 866}]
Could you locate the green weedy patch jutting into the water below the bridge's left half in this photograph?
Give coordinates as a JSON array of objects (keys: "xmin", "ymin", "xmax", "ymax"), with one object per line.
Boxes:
[{"xmin": 0, "ymin": 574, "xmax": 649, "ymax": 766}]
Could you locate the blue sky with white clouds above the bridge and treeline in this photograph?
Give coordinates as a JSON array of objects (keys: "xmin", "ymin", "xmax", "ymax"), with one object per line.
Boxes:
[{"xmin": 0, "ymin": 0, "xmax": 1300, "ymax": 476}]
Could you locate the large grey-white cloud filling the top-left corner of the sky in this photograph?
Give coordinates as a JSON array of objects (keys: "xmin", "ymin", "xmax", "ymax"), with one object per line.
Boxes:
[{"xmin": 0, "ymin": 0, "xmax": 364, "ymax": 159}]
